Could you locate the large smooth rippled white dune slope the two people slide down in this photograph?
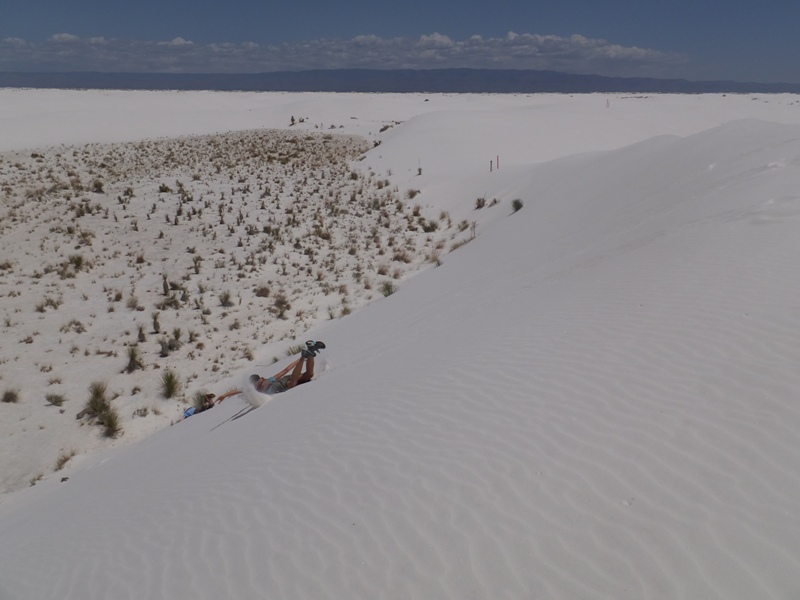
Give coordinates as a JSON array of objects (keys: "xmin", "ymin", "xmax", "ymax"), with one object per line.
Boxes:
[{"xmin": 0, "ymin": 91, "xmax": 800, "ymax": 600}]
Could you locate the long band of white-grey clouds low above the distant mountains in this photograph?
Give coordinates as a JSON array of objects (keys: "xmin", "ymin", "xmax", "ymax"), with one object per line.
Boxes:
[{"xmin": 0, "ymin": 32, "xmax": 688, "ymax": 77}]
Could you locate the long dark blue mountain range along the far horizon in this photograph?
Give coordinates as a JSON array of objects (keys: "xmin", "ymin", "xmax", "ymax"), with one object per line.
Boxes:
[{"xmin": 0, "ymin": 69, "xmax": 800, "ymax": 94}]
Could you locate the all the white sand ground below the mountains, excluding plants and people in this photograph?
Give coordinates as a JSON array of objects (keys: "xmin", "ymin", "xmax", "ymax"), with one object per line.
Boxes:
[{"xmin": 0, "ymin": 91, "xmax": 800, "ymax": 599}]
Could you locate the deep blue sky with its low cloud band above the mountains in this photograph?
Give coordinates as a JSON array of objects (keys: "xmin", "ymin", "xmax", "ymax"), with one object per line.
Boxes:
[{"xmin": 0, "ymin": 0, "xmax": 800, "ymax": 83}]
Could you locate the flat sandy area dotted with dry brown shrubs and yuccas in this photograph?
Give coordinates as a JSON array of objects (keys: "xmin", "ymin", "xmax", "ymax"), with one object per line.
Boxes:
[{"xmin": 0, "ymin": 130, "xmax": 460, "ymax": 492}]
